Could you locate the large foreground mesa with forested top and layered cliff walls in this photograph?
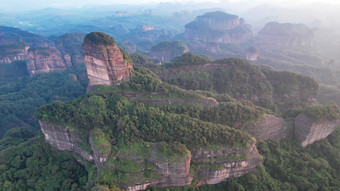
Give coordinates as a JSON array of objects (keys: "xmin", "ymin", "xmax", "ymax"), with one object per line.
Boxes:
[{"xmin": 37, "ymin": 69, "xmax": 262, "ymax": 190}]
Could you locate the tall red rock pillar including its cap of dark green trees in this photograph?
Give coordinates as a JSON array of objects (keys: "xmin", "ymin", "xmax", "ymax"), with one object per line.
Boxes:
[{"xmin": 82, "ymin": 32, "xmax": 132, "ymax": 91}]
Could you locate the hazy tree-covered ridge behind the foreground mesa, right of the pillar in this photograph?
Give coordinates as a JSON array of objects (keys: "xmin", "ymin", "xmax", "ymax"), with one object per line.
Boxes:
[{"xmin": 149, "ymin": 54, "xmax": 318, "ymax": 112}]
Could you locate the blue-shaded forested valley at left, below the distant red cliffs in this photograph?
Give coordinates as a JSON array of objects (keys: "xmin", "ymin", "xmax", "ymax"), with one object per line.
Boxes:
[{"xmin": 0, "ymin": 62, "xmax": 87, "ymax": 136}]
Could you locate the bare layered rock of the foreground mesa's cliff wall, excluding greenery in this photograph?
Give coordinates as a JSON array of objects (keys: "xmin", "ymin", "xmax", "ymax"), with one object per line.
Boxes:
[{"xmin": 39, "ymin": 121, "xmax": 262, "ymax": 191}]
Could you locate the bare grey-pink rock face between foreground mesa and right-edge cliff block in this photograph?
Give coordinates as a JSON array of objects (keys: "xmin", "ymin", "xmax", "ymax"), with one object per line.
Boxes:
[{"xmin": 244, "ymin": 114, "xmax": 289, "ymax": 141}]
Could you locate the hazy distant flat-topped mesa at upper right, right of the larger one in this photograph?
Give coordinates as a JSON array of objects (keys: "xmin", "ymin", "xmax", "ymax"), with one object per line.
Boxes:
[{"xmin": 254, "ymin": 22, "xmax": 314, "ymax": 51}]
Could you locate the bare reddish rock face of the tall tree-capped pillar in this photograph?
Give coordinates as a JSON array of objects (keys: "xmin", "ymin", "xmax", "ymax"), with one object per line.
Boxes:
[{"xmin": 83, "ymin": 42, "xmax": 132, "ymax": 90}]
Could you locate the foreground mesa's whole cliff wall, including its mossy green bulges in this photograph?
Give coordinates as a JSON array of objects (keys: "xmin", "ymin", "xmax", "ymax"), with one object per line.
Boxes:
[{"xmin": 39, "ymin": 121, "xmax": 262, "ymax": 191}]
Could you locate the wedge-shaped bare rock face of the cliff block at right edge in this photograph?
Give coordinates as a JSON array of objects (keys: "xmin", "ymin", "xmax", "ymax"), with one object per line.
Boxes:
[{"xmin": 295, "ymin": 113, "xmax": 340, "ymax": 147}]
